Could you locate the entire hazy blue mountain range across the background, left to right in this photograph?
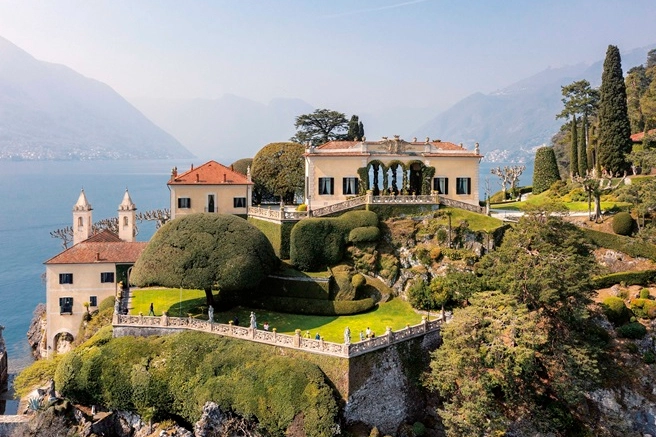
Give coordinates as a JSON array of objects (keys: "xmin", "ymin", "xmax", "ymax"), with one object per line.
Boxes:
[{"xmin": 0, "ymin": 34, "xmax": 656, "ymax": 163}]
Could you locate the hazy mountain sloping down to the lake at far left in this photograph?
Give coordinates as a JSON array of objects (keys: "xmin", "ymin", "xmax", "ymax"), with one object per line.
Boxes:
[{"xmin": 0, "ymin": 38, "xmax": 192, "ymax": 159}]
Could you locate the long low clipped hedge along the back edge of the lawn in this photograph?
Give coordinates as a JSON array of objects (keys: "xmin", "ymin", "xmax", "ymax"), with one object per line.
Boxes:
[{"xmin": 249, "ymin": 296, "xmax": 376, "ymax": 316}]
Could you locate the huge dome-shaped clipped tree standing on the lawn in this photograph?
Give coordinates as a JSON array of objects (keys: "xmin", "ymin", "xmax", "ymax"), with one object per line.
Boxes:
[{"xmin": 131, "ymin": 213, "xmax": 279, "ymax": 305}]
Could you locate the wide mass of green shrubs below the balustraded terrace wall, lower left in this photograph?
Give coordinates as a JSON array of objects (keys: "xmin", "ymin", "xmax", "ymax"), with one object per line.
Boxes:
[{"xmin": 55, "ymin": 331, "xmax": 337, "ymax": 437}]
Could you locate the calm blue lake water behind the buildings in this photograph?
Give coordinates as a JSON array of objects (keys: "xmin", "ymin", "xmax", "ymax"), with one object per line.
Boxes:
[{"xmin": 0, "ymin": 161, "xmax": 533, "ymax": 373}]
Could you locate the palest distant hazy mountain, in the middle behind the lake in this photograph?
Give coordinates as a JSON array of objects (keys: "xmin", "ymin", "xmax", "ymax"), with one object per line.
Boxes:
[{"xmin": 132, "ymin": 94, "xmax": 314, "ymax": 164}]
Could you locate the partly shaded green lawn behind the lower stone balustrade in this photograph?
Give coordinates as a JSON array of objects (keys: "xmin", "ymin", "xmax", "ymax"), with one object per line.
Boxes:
[{"xmin": 130, "ymin": 289, "xmax": 426, "ymax": 342}]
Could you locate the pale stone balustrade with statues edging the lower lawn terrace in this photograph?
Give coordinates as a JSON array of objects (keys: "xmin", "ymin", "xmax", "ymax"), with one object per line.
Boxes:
[{"xmin": 113, "ymin": 314, "xmax": 442, "ymax": 358}]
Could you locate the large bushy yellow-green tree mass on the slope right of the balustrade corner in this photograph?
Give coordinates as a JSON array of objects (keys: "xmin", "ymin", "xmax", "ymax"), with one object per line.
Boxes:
[{"xmin": 427, "ymin": 214, "xmax": 603, "ymax": 436}]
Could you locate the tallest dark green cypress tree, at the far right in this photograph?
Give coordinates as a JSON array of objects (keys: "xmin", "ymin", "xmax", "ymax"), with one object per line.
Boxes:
[{"xmin": 597, "ymin": 46, "xmax": 632, "ymax": 174}]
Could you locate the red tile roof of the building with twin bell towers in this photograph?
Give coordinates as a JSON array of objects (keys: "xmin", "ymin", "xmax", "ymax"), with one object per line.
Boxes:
[{"xmin": 45, "ymin": 230, "xmax": 148, "ymax": 264}]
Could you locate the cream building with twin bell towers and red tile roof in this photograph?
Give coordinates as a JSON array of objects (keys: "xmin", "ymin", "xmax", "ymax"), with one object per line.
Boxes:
[{"xmin": 45, "ymin": 190, "xmax": 148, "ymax": 356}]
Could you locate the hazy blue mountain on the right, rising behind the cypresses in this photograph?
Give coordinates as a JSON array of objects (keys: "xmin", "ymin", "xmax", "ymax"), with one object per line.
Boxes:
[{"xmin": 415, "ymin": 46, "xmax": 655, "ymax": 161}]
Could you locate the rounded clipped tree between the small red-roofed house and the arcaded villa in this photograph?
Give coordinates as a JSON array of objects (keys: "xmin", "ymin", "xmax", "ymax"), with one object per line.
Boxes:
[{"xmin": 251, "ymin": 142, "xmax": 305, "ymax": 203}]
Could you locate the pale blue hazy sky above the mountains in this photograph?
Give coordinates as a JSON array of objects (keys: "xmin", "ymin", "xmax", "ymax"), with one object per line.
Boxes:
[{"xmin": 0, "ymin": 0, "xmax": 656, "ymax": 113}]
